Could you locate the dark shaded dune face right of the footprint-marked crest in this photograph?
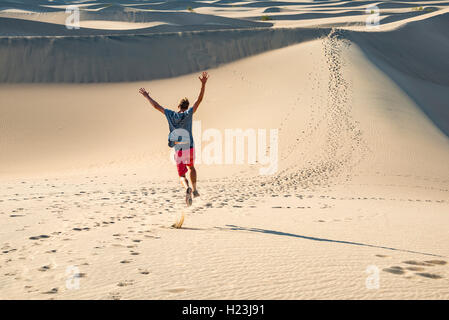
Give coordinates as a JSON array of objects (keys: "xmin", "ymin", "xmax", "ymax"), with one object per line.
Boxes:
[{"xmin": 350, "ymin": 13, "xmax": 449, "ymax": 136}]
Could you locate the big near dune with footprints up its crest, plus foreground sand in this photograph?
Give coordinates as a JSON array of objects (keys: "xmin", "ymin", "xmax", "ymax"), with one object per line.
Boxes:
[{"xmin": 0, "ymin": 2, "xmax": 449, "ymax": 299}]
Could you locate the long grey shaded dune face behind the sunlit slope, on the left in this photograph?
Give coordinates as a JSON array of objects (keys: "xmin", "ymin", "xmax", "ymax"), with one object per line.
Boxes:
[{"xmin": 0, "ymin": 29, "xmax": 325, "ymax": 83}]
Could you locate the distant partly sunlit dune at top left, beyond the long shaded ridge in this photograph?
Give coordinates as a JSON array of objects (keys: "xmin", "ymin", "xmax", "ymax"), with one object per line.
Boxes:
[{"xmin": 0, "ymin": 6, "xmax": 272, "ymax": 36}]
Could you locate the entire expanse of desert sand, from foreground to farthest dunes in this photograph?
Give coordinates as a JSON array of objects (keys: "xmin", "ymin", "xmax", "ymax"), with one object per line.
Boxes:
[{"xmin": 0, "ymin": 0, "xmax": 449, "ymax": 299}]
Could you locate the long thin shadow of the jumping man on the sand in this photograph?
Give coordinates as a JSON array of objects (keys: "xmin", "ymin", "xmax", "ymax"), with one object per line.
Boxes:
[{"xmin": 215, "ymin": 224, "xmax": 444, "ymax": 257}]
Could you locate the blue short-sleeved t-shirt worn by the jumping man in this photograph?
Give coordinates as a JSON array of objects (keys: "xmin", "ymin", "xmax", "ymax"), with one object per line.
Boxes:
[{"xmin": 164, "ymin": 107, "xmax": 194, "ymax": 150}]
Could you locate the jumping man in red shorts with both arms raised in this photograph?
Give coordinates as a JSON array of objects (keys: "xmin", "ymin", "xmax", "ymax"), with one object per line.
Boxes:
[{"xmin": 139, "ymin": 72, "xmax": 209, "ymax": 206}]
